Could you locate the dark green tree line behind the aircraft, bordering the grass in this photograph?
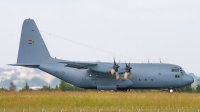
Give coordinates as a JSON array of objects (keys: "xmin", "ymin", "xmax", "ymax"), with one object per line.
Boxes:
[{"xmin": 0, "ymin": 80, "xmax": 200, "ymax": 93}]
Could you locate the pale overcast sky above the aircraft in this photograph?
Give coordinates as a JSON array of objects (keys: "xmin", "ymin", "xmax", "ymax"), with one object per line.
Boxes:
[{"xmin": 0, "ymin": 0, "xmax": 200, "ymax": 76}]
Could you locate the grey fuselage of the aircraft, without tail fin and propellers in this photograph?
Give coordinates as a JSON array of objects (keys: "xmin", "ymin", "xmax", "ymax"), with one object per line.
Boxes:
[{"xmin": 38, "ymin": 59, "xmax": 194, "ymax": 90}]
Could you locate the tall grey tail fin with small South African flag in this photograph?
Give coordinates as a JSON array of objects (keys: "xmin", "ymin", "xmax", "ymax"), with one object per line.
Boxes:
[{"xmin": 17, "ymin": 19, "xmax": 51, "ymax": 65}]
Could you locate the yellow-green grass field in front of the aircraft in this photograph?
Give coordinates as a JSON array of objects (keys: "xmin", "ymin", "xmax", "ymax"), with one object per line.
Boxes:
[{"xmin": 0, "ymin": 91, "xmax": 200, "ymax": 112}]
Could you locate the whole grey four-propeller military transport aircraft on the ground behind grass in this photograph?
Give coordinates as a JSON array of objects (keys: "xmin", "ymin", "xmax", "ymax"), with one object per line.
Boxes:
[{"xmin": 10, "ymin": 19, "xmax": 194, "ymax": 93}]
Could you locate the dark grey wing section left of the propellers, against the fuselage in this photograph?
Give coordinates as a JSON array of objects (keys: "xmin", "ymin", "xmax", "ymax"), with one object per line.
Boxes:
[{"xmin": 60, "ymin": 61, "xmax": 98, "ymax": 69}]
